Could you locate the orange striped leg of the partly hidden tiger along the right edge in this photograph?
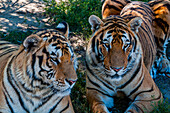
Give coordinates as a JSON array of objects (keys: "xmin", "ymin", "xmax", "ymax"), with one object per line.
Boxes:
[{"xmin": 148, "ymin": 0, "xmax": 170, "ymax": 74}]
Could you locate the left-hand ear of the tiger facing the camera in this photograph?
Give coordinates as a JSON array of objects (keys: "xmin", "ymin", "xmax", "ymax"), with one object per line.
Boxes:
[{"xmin": 89, "ymin": 15, "xmax": 103, "ymax": 32}]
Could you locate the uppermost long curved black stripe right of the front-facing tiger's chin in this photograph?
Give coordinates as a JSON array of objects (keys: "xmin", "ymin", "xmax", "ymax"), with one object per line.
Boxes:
[{"xmin": 117, "ymin": 59, "xmax": 142, "ymax": 89}]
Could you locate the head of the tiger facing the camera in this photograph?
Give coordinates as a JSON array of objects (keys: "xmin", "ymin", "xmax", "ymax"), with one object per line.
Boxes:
[{"xmin": 86, "ymin": 15, "xmax": 142, "ymax": 80}]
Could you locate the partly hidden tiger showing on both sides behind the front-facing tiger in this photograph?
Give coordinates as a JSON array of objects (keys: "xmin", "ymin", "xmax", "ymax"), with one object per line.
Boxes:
[{"xmin": 102, "ymin": 0, "xmax": 170, "ymax": 77}]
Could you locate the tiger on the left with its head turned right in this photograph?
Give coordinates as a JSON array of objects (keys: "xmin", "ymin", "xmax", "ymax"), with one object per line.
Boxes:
[{"xmin": 0, "ymin": 22, "xmax": 77, "ymax": 113}]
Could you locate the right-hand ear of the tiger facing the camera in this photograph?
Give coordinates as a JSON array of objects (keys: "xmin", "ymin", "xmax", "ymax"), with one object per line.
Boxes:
[{"xmin": 128, "ymin": 17, "xmax": 143, "ymax": 33}]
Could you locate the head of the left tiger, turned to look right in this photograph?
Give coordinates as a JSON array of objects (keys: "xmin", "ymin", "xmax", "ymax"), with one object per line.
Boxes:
[{"xmin": 16, "ymin": 22, "xmax": 77, "ymax": 96}]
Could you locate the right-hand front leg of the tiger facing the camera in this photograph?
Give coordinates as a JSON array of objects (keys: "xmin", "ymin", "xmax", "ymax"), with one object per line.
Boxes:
[{"xmin": 125, "ymin": 67, "xmax": 163, "ymax": 113}]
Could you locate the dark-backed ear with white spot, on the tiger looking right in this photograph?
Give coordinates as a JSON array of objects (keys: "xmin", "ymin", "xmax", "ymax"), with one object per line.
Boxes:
[{"xmin": 56, "ymin": 22, "xmax": 69, "ymax": 38}]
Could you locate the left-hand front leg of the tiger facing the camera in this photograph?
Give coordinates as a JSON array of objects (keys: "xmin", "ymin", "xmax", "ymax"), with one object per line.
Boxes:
[{"xmin": 86, "ymin": 88, "xmax": 113, "ymax": 113}]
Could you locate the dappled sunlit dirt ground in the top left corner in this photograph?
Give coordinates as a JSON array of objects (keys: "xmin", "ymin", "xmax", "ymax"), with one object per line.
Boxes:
[{"xmin": 0, "ymin": 0, "xmax": 48, "ymax": 32}]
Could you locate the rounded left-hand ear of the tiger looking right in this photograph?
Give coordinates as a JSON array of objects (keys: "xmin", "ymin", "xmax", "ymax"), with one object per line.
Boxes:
[{"xmin": 23, "ymin": 34, "xmax": 42, "ymax": 52}]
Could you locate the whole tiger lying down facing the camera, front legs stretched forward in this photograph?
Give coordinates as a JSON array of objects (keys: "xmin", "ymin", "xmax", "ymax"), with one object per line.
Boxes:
[{"xmin": 86, "ymin": 2, "xmax": 163, "ymax": 113}]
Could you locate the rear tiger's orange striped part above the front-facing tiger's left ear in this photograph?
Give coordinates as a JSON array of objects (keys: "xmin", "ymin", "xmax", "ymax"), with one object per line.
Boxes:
[{"xmin": 102, "ymin": 0, "xmax": 131, "ymax": 19}]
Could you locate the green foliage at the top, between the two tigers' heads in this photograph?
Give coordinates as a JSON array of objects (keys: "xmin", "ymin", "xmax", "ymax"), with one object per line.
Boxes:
[{"xmin": 44, "ymin": 0, "xmax": 102, "ymax": 36}]
